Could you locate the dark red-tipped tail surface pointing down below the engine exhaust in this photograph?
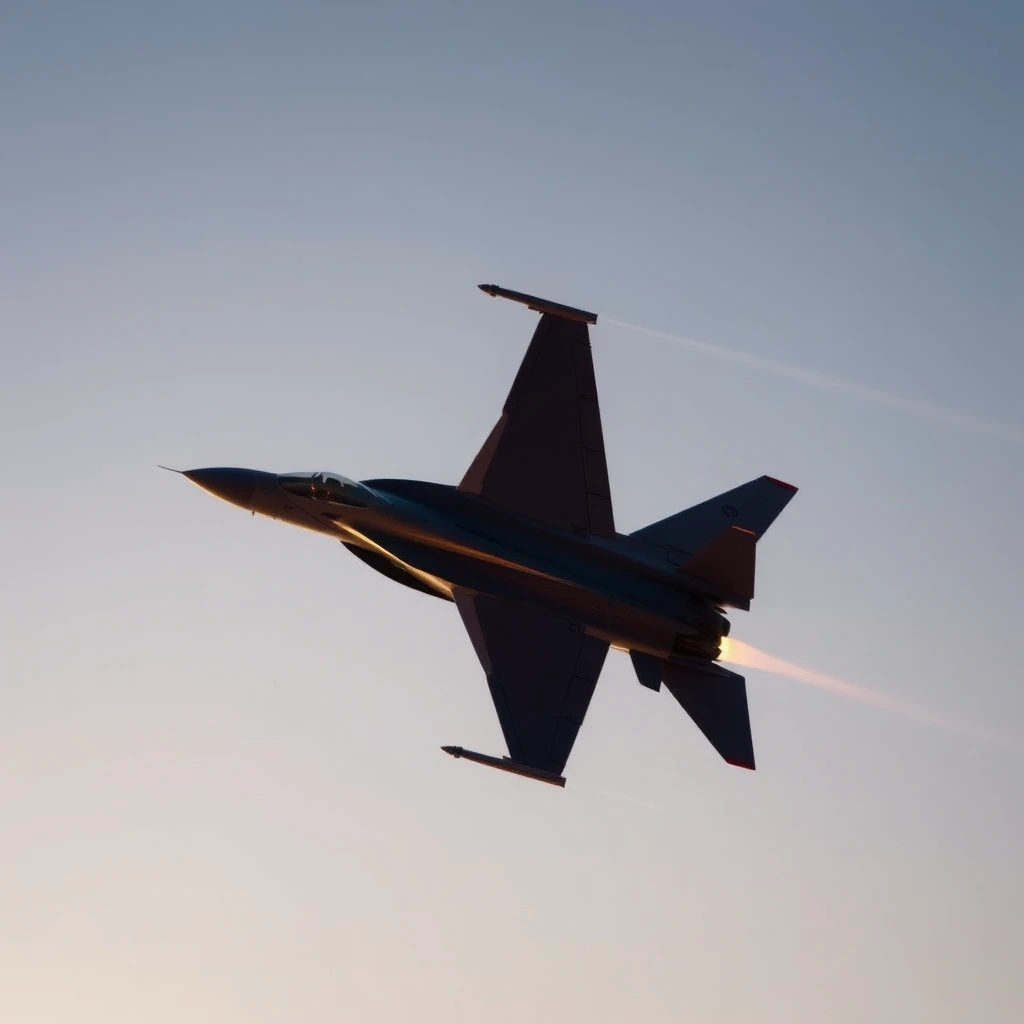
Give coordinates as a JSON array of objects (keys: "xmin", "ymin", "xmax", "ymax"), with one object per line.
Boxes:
[{"xmin": 664, "ymin": 662, "xmax": 754, "ymax": 770}]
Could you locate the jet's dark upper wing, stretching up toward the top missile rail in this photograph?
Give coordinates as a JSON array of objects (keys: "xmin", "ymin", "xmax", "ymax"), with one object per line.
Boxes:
[{"xmin": 459, "ymin": 299, "xmax": 615, "ymax": 538}]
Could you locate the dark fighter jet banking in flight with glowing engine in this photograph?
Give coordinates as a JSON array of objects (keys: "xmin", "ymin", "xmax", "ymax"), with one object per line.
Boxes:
[{"xmin": 178, "ymin": 285, "xmax": 797, "ymax": 786}]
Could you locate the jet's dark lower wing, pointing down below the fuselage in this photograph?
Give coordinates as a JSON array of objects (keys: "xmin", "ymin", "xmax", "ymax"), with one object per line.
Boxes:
[{"xmin": 455, "ymin": 590, "xmax": 608, "ymax": 775}]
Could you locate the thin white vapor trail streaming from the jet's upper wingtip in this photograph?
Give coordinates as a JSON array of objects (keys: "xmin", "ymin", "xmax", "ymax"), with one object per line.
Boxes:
[{"xmin": 604, "ymin": 316, "xmax": 1024, "ymax": 444}]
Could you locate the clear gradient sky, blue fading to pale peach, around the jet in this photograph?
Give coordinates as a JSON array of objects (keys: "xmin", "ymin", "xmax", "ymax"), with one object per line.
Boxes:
[{"xmin": 0, "ymin": 0, "xmax": 1024, "ymax": 1024}]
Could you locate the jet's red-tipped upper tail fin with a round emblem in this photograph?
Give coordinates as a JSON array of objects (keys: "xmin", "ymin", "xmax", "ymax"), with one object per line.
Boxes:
[{"xmin": 630, "ymin": 476, "xmax": 797, "ymax": 564}]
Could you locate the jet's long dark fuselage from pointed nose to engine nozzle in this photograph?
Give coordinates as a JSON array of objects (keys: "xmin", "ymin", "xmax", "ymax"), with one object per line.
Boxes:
[{"xmin": 185, "ymin": 468, "xmax": 729, "ymax": 659}]
